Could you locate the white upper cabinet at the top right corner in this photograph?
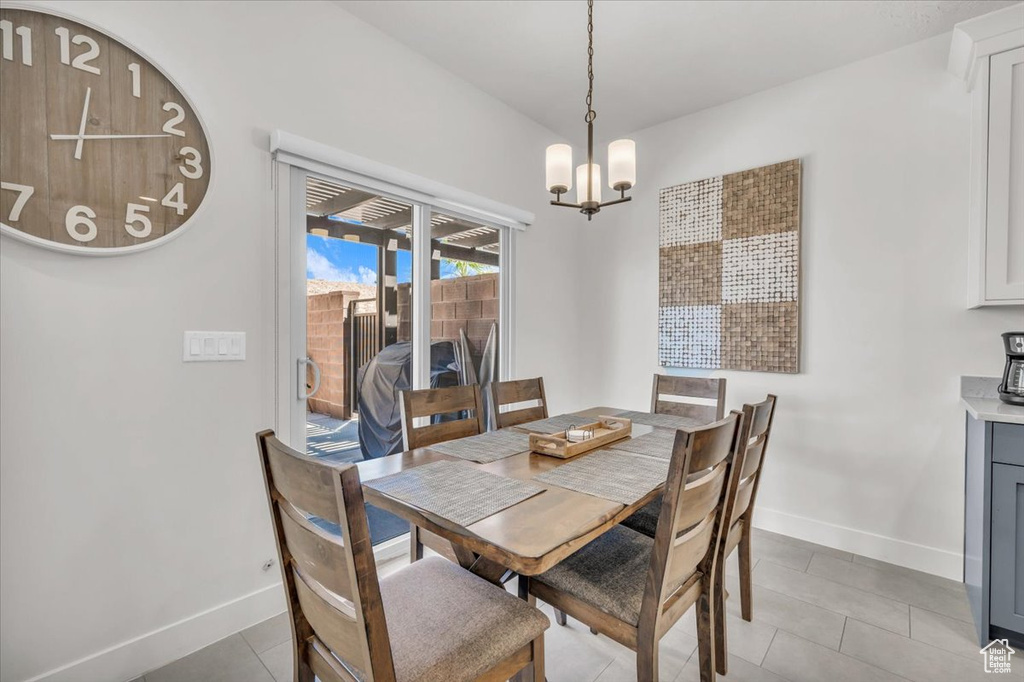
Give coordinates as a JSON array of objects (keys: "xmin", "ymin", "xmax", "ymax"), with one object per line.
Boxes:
[{"xmin": 949, "ymin": 4, "xmax": 1024, "ymax": 308}]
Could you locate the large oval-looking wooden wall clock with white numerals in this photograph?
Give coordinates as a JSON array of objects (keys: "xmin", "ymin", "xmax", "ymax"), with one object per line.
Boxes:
[{"xmin": 0, "ymin": 5, "xmax": 212, "ymax": 255}]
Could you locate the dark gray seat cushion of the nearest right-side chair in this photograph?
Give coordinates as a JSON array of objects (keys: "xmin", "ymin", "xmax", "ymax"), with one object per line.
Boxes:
[{"xmin": 534, "ymin": 525, "xmax": 654, "ymax": 625}]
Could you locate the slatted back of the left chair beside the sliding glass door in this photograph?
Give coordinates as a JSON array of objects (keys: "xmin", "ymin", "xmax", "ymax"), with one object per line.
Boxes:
[{"xmin": 401, "ymin": 384, "xmax": 485, "ymax": 450}]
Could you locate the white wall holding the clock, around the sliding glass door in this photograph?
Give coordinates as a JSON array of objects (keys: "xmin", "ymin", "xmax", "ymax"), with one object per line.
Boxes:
[{"xmin": 0, "ymin": 2, "xmax": 582, "ymax": 682}]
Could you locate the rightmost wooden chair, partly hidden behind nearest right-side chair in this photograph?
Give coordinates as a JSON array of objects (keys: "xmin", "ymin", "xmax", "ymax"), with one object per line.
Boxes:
[{"xmin": 716, "ymin": 394, "xmax": 776, "ymax": 675}]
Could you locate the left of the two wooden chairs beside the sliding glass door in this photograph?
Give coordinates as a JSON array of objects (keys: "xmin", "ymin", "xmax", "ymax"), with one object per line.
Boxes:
[{"xmin": 400, "ymin": 384, "xmax": 485, "ymax": 561}]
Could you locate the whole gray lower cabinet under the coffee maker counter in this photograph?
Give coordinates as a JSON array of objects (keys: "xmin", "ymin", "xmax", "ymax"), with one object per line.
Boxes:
[{"xmin": 964, "ymin": 415, "xmax": 1024, "ymax": 646}]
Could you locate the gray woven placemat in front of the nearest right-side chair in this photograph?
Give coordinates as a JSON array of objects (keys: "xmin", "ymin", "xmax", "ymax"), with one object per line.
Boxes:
[{"xmin": 535, "ymin": 450, "xmax": 669, "ymax": 505}]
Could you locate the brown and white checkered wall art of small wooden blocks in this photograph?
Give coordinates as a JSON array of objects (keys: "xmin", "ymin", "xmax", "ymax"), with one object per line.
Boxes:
[{"xmin": 657, "ymin": 159, "xmax": 800, "ymax": 373}]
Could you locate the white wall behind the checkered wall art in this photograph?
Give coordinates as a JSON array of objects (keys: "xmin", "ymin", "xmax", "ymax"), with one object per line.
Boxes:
[{"xmin": 582, "ymin": 36, "xmax": 1024, "ymax": 580}]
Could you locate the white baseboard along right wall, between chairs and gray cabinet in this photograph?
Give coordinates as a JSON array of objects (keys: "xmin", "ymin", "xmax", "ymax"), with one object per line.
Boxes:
[{"xmin": 754, "ymin": 507, "xmax": 964, "ymax": 582}]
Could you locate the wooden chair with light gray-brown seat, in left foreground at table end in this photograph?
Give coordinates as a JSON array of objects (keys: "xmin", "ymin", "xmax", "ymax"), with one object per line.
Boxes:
[{"xmin": 256, "ymin": 431, "xmax": 548, "ymax": 682}]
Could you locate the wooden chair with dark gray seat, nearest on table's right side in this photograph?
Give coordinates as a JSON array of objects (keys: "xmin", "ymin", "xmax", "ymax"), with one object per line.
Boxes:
[{"xmin": 529, "ymin": 412, "xmax": 742, "ymax": 682}]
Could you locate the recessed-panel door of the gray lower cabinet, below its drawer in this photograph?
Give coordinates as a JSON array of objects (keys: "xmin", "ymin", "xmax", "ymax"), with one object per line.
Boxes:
[{"xmin": 989, "ymin": 464, "xmax": 1024, "ymax": 632}]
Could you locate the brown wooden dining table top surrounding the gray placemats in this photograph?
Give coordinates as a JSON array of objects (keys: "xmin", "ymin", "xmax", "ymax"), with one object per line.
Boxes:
[{"xmin": 358, "ymin": 407, "xmax": 696, "ymax": 583}]
